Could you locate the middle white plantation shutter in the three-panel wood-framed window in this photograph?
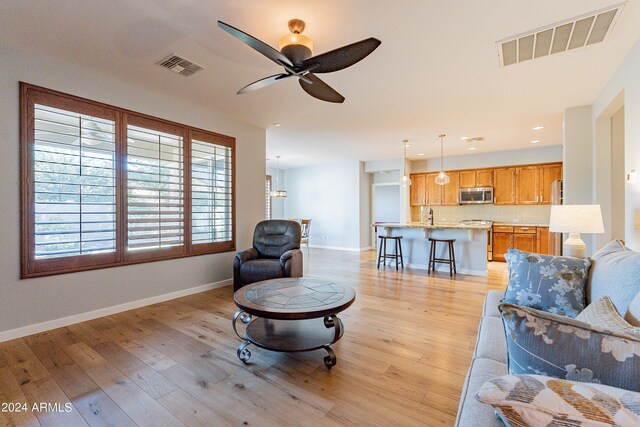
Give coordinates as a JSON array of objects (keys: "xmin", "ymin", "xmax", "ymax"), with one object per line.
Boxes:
[{"xmin": 126, "ymin": 118, "xmax": 185, "ymax": 258}]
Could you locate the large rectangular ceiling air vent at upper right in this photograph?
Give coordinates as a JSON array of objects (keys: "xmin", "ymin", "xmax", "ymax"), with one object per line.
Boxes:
[{"xmin": 496, "ymin": 2, "xmax": 626, "ymax": 67}]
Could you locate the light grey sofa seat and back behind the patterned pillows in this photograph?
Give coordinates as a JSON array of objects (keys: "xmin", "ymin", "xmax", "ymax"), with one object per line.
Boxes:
[{"xmin": 455, "ymin": 241, "xmax": 640, "ymax": 427}]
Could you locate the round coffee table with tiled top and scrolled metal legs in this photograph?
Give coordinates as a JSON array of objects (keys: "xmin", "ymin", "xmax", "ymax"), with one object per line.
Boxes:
[{"xmin": 233, "ymin": 277, "xmax": 356, "ymax": 369}]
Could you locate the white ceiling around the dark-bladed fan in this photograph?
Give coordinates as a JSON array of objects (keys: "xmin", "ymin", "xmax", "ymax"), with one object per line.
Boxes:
[{"xmin": 0, "ymin": 0, "xmax": 640, "ymax": 167}]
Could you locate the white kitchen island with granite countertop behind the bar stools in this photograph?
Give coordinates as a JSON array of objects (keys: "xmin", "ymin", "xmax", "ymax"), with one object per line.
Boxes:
[{"xmin": 373, "ymin": 221, "xmax": 492, "ymax": 276}]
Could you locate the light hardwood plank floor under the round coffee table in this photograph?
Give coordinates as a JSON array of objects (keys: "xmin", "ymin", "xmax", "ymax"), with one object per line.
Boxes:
[{"xmin": 0, "ymin": 249, "xmax": 506, "ymax": 427}]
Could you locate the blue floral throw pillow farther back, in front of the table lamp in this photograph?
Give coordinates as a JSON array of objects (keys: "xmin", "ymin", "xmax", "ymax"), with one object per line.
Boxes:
[{"xmin": 503, "ymin": 248, "xmax": 591, "ymax": 317}]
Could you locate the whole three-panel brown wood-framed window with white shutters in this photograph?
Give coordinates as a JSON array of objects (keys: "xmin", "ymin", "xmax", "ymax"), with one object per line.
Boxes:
[{"xmin": 21, "ymin": 83, "xmax": 235, "ymax": 278}]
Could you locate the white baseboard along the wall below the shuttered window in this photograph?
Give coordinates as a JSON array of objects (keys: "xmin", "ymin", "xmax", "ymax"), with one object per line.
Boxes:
[{"xmin": 0, "ymin": 279, "xmax": 233, "ymax": 342}]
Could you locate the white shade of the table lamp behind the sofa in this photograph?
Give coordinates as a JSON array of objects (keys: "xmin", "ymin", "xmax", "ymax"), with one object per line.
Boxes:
[{"xmin": 549, "ymin": 205, "xmax": 604, "ymax": 234}]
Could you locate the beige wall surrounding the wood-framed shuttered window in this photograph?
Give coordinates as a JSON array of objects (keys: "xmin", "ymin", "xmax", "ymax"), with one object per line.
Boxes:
[{"xmin": 0, "ymin": 45, "xmax": 265, "ymax": 334}]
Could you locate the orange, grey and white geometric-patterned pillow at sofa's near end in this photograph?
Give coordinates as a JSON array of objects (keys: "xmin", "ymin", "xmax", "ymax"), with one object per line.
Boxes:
[{"xmin": 476, "ymin": 375, "xmax": 640, "ymax": 427}]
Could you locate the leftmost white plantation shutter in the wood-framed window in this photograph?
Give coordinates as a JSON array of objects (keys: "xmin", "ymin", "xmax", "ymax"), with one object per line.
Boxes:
[{"xmin": 33, "ymin": 104, "xmax": 116, "ymax": 260}]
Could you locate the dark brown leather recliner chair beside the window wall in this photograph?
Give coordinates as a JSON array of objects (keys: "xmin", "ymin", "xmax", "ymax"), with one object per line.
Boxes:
[{"xmin": 233, "ymin": 219, "xmax": 302, "ymax": 291}]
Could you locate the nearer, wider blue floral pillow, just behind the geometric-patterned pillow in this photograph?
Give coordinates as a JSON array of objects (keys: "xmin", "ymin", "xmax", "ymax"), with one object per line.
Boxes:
[{"xmin": 499, "ymin": 304, "xmax": 640, "ymax": 391}]
